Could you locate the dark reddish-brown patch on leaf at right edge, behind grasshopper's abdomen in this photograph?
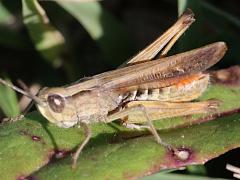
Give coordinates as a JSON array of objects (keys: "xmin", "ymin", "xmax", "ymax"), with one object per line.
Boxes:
[{"xmin": 211, "ymin": 66, "xmax": 240, "ymax": 86}]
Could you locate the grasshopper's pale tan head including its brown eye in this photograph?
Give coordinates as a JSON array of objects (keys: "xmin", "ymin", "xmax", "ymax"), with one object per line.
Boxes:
[{"xmin": 36, "ymin": 88, "xmax": 78, "ymax": 128}]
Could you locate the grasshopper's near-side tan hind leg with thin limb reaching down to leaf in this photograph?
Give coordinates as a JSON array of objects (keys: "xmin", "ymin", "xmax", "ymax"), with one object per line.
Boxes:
[{"xmin": 105, "ymin": 100, "xmax": 220, "ymax": 155}]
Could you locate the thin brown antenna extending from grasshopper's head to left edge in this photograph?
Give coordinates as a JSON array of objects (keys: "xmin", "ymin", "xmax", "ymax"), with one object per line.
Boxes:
[{"xmin": 0, "ymin": 78, "xmax": 44, "ymax": 106}]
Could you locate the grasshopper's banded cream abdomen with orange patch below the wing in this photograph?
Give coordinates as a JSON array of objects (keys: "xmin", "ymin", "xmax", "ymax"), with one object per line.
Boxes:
[{"xmin": 121, "ymin": 74, "xmax": 209, "ymax": 103}]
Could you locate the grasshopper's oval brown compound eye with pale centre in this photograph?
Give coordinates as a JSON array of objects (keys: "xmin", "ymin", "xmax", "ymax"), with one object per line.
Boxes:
[{"xmin": 47, "ymin": 94, "xmax": 65, "ymax": 113}]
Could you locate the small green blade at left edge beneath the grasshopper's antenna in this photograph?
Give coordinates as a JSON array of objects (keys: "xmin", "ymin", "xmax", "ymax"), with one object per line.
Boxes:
[{"xmin": 0, "ymin": 79, "xmax": 20, "ymax": 117}]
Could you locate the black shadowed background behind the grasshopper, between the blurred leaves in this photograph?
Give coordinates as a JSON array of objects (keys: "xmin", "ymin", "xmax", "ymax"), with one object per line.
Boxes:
[{"xmin": 0, "ymin": 0, "xmax": 240, "ymax": 86}]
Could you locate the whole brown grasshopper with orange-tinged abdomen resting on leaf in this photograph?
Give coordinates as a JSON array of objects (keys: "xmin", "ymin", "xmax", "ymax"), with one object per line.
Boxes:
[{"xmin": 0, "ymin": 10, "xmax": 227, "ymax": 167}]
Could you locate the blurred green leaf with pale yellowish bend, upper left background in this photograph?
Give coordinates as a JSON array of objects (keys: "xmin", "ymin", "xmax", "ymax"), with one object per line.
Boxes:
[{"xmin": 22, "ymin": 0, "xmax": 64, "ymax": 67}]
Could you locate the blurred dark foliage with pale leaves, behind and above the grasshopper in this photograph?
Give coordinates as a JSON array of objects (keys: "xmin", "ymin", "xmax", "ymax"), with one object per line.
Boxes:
[{"xmin": 0, "ymin": 0, "xmax": 240, "ymax": 179}]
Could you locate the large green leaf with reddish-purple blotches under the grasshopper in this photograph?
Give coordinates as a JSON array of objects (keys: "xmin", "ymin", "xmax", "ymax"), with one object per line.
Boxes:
[{"xmin": 0, "ymin": 79, "xmax": 240, "ymax": 179}]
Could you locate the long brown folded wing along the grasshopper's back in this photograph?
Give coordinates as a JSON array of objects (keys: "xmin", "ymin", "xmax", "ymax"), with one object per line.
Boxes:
[{"xmin": 93, "ymin": 42, "xmax": 227, "ymax": 91}]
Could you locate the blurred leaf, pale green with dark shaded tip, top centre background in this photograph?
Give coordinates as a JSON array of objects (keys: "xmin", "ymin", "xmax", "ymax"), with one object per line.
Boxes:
[{"xmin": 57, "ymin": 1, "xmax": 133, "ymax": 64}]
